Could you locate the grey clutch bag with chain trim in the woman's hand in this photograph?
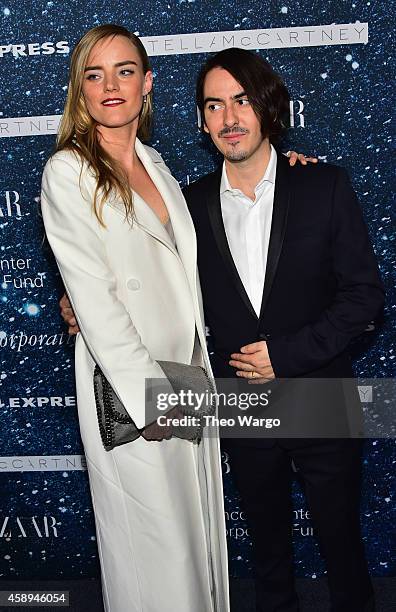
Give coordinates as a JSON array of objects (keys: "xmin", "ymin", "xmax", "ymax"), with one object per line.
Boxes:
[{"xmin": 93, "ymin": 361, "xmax": 216, "ymax": 451}]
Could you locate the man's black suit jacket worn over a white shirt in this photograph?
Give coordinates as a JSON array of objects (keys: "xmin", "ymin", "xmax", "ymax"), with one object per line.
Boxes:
[{"xmin": 184, "ymin": 155, "xmax": 384, "ymax": 446}]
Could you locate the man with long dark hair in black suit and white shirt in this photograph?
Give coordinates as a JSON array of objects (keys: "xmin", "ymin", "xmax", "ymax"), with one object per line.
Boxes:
[{"xmin": 184, "ymin": 49, "xmax": 383, "ymax": 612}]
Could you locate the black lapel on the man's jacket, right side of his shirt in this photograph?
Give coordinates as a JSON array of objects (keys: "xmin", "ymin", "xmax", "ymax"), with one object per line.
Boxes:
[{"xmin": 260, "ymin": 154, "xmax": 291, "ymax": 319}]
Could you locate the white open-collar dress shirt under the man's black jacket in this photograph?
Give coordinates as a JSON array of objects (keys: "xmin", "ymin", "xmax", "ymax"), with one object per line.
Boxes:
[{"xmin": 220, "ymin": 145, "xmax": 276, "ymax": 316}]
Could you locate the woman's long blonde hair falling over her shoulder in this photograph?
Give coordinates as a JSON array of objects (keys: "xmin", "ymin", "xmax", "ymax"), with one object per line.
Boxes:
[{"xmin": 56, "ymin": 24, "xmax": 153, "ymax": 226}]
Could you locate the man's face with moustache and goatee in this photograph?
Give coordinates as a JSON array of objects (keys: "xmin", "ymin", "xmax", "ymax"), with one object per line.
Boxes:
[{"xmin": 204, "ymin": 68, "xmax": 265, "ymax": 162}]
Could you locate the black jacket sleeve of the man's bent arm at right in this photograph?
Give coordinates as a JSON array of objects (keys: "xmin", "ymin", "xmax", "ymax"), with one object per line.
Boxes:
[{"xmin": 267, "ymin": 168, "xmax": 384, "ymax": 377}]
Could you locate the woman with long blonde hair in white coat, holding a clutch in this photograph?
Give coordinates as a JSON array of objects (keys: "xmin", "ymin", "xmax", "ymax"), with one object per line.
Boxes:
[{"xmin": 41, "ymin": 25, "xmax": 229, "ymax": 612}]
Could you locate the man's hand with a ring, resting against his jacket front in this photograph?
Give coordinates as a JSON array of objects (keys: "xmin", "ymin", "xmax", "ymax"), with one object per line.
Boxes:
[{"xmin": 229, "ymin": 340, "xmax": 275, "ymax": 384}]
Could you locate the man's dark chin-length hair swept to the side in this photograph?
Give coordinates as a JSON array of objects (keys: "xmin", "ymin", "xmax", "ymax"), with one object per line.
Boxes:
[{"xmin": 196, "ymin": 48, "xmax": 290, "ymax": 143}]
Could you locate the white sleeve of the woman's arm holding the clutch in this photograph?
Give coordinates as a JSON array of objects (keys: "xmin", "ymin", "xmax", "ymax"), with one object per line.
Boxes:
[{"xmin": 41, "ymin": 156, "xmax": 172, "ymax": 429}]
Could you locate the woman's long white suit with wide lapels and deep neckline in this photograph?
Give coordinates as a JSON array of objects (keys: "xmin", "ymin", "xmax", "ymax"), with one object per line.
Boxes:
[{"xmin": 41, "ymin": 140, "xmax": 229, "ymax": 612}]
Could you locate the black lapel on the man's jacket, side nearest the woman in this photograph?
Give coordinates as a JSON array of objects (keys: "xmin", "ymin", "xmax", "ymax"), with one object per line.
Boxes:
[{"xmin": 206, "ymin": 168, "xmax": 258, "ymax": 319}]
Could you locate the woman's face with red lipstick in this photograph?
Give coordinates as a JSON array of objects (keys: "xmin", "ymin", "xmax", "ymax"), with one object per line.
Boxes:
[{"xmin": 82, "ymin": 36, "xmax": 153, "ymax": 128}]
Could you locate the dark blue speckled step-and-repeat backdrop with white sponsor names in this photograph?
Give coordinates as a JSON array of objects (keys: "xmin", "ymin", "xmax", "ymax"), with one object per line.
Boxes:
[{"xmin": 0, "ymin": 0, "xmax": 395, "ymax": 579}]
